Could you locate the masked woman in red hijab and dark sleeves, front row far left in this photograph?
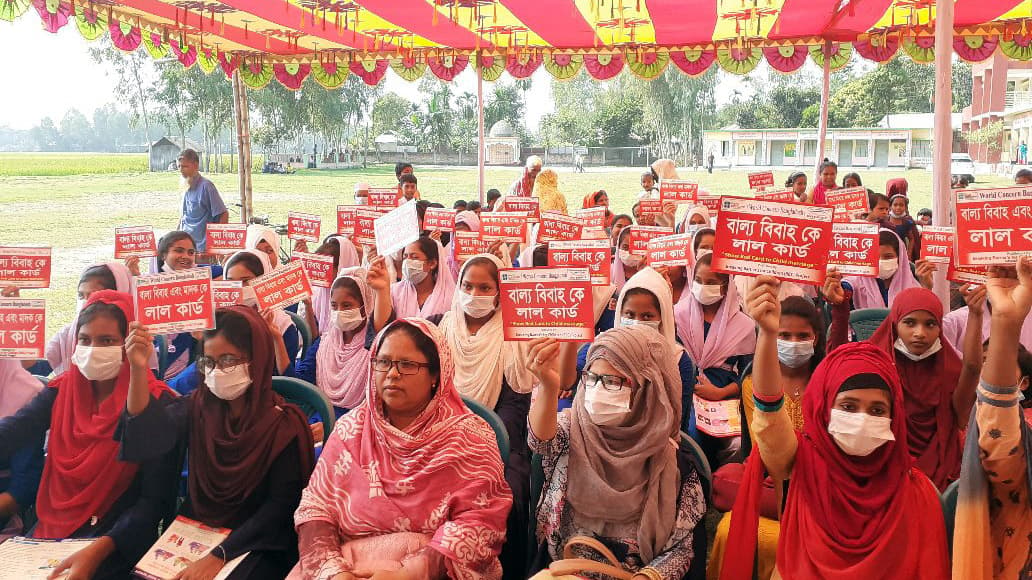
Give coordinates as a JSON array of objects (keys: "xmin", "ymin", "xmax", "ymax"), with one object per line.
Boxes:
[{"xmin": 0, "ymin": 290, "xmax": 179, "ymax": 579}]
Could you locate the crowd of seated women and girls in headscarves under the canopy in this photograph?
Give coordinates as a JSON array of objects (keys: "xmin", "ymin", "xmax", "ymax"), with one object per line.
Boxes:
[{"xmin": 0, "ymin": 157, "xmax": 1032, "ymax": 580}]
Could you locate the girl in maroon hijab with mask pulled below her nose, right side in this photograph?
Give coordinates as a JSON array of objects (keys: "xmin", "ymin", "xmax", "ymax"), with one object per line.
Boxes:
[{"xmin": 869, "ymin": 288, "xmax": 985, "ymax": 490}]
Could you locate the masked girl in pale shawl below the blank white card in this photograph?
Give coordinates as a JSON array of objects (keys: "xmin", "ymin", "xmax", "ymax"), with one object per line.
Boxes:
[{"xmin": 390, "ymin": 236, "xmax": 455, "ymax": 318}]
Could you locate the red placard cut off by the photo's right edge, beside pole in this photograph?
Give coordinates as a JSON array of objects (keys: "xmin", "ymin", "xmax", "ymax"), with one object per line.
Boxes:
[{"xmin": 954, "ymin": 187, "xmax": 1032, "ymax": 267}]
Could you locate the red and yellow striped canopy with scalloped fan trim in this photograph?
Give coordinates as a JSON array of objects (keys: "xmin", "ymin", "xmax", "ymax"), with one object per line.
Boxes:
[{"xmin": 8, "ymin": 0, "xmax": 1032, "ymax": 89}]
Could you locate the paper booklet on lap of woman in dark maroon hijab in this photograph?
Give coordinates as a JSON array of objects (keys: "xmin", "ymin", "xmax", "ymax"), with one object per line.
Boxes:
[{"xmin": 135, "ymin": 516, "xmax": 248, "ymax": 580}]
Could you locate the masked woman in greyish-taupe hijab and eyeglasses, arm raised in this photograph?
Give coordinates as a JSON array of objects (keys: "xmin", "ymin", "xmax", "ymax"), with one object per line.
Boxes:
[{"xmin": 529, "ymin": 325, "xmax": 706, "ymax": 580}]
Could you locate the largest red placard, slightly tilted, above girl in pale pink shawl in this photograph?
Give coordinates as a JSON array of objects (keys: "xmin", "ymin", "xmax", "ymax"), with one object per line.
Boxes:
[{"xmin": 713, "ymin": 197, "xmax": 834, "ymax": 285}]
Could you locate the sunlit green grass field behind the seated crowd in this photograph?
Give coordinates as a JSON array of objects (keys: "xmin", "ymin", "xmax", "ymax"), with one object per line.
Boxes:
[{"xmin": 0, "ymin": 154, "xmax": 1007, "ymax": 332}]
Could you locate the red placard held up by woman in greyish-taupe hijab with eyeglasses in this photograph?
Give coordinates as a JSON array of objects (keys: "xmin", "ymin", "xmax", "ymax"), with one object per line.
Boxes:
[{"xmin": 498, "ymin": 268, "xmax": 594, "ymax": 343}]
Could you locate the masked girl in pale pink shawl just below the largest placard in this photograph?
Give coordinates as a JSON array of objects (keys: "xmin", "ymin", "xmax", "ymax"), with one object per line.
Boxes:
[{"xmin": 674, "ymin": 254, "xmax": 756, "ymax": 468}]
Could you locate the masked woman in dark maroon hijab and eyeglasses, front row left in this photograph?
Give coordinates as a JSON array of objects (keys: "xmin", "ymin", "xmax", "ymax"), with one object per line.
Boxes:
[{"xmin": 120, "ymin": 305, "xmax": 315, "ymax": 580}]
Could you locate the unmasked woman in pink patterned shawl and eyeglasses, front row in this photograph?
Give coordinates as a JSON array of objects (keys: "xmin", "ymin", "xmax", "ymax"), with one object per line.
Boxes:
[{"xmin": 294, "ymin": 319, "xmax": 512, "ymax": 579}]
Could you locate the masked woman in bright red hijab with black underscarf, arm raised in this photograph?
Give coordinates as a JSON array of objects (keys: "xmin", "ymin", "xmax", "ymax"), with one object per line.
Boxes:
[{"xmin": 720, "ymin": 277, "xmax": 949, "ymax": 580}]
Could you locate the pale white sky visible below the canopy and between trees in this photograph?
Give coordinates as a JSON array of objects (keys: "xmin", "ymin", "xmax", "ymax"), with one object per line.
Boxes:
[{"xmin": 0, "ymin": 13, "xmax": 759, "ymax": 131}]
